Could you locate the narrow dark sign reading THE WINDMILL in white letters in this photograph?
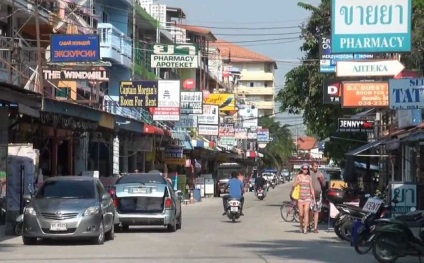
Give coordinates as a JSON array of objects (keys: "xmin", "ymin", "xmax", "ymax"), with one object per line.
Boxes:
[{"xmin": 43, "ymin": 69, "xmax": 109, "ymax": 81}]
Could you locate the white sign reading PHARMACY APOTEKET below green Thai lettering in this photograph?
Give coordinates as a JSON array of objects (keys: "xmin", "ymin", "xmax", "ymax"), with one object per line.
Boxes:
[{"xmin": 150, "ymin": 44, "xmax": 199, "ymax": 68}]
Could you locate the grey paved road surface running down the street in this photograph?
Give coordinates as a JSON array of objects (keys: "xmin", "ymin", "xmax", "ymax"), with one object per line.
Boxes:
[{"xmin": 0, "ymin": 184, "xmax": 418, "ymax": 263}]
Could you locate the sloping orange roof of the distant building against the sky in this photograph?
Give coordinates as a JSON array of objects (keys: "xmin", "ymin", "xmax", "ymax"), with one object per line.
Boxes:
[{"xmin": 210, "ymin": 39, "xmax": 277, "ymax": 68}]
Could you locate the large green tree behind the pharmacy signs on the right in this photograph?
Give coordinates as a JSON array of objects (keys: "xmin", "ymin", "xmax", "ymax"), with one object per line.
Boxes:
[{"xmin": 276, "ymin": 0, "xmax": 424, "ymax": 165}]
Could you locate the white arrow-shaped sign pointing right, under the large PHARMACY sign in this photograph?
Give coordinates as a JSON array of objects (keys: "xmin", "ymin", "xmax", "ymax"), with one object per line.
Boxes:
[{"xmin": 336, "ymin": 59, "xmax": 405, "ymax": 77}]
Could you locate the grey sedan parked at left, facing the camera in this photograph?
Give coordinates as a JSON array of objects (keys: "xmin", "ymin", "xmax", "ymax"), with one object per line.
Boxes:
[{"xmin": 22, "ymin": 176, "xmax": 115, "ymax": 245}]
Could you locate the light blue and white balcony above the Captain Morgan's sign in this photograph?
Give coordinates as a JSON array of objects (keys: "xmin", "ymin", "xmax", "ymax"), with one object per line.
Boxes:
[{"xmin": 97, "ymin": 23, "xmax": 132, "ymax": 68}]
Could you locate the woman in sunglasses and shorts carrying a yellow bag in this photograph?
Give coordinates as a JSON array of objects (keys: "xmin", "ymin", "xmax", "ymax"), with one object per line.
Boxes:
[{"xmin": 293, "ymin": 164, "xmax": 315, "ymax": 234}]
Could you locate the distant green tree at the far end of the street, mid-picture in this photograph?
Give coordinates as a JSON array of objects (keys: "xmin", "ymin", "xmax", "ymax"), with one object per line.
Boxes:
[{"xmin": 259, "ymin": 117, "xmax": 295, "ymax": 170}]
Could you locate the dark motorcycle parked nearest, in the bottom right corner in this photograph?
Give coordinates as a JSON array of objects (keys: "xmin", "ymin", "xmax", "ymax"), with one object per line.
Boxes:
[{"xmin": 370, "ymin": 211, "xmax": 424, "ymax": 263}]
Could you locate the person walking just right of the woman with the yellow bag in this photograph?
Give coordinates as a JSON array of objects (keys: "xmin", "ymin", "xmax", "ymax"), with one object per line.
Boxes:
[{"xmin": 309, "ymin": 162, "xmax": 325, "ymax": 233}]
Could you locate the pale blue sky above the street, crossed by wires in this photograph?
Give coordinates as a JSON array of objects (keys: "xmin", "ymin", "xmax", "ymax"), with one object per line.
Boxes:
[{"xmin": 161, "ymin": 0, "xmax": 320, "ymax": 131}]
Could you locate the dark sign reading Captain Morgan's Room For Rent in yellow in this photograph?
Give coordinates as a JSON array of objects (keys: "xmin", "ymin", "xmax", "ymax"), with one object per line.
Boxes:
[{"xmin": 119, "ymin": 80, "xmax": 158, "ymax": 107}]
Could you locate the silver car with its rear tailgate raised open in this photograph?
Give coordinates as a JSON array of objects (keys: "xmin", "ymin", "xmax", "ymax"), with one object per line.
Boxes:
[{"xmin": 112, "ymin": 173, "xmax": 182, "ymax": 232}]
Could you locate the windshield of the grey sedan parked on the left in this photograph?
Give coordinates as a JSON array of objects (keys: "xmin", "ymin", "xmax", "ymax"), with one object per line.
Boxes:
[{"xmin": 35, "ymin": 180, "xmax": 96, "ymax": 199}]
